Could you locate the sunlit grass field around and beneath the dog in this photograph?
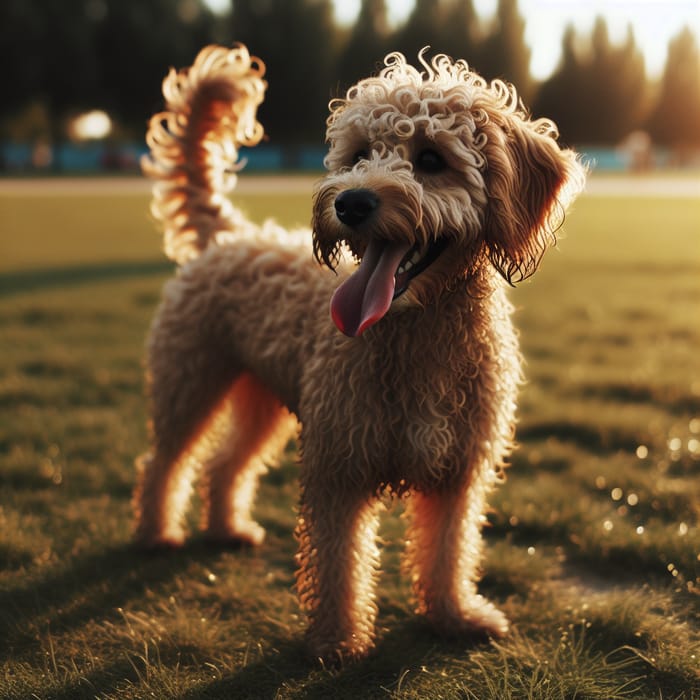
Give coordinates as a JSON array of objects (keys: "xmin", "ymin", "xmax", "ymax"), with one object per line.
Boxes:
[{"xmin": 0, "ymin": 178, "xmax": 700, "ymax": 700}]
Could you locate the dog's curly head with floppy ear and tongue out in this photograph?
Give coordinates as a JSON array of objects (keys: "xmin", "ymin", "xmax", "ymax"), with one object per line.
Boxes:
[{"xmin": 313, "ymin": 53, "xmax": 584, "ymax": 336}]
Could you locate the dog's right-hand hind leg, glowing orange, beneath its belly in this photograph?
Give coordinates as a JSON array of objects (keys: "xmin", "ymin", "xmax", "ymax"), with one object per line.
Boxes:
[{"xmin": 202, "ymin": 374, "xmax": 296, "ymax": 545}]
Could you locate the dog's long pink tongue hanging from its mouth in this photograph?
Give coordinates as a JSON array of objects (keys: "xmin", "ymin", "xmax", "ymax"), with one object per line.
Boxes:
[{"xmin": 331, "ymin": 238, "xmax": 410, "ymax": 337}]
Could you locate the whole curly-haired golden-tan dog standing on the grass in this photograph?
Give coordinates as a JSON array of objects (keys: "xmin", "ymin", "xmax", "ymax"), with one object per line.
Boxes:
[{"xmin": 135, "ymin": 46, "xmax": 584, "ymax": 659}]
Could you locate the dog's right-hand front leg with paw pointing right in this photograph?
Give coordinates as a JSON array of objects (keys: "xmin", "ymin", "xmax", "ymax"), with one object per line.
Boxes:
[{"xmin": 406, "ymin": 477, "xmax": 508, "ymax": 637}]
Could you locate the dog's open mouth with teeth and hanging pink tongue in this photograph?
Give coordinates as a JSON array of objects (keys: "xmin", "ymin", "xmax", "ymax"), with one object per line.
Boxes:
[{"xmin": 331, "ymin": 238, "xmax": 447, "ymax": 337}]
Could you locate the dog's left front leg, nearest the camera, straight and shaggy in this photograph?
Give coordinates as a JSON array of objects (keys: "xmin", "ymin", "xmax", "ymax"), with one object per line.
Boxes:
[{"xmin": 296, "ymin": 484, "xmax": 380, "ymax": 663}]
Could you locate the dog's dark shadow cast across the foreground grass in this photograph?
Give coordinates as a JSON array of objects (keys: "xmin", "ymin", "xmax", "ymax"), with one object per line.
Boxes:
[{"xmin": 0, "ymin": 540, "xmax": 498, "ymax": 700}]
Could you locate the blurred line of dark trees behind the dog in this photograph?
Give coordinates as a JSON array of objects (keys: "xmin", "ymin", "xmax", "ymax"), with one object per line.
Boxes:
[{"xmin": 0, "ymin": 0, "xmax": 700, "ymax": 148}]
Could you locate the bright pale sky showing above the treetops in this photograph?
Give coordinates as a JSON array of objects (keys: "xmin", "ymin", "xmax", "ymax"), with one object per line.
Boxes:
[{"xmin": 206, "ymin": 0, "xmax": 700, "ymax": 80}]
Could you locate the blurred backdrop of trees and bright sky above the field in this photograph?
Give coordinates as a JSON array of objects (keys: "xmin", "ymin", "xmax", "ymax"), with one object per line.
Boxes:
[{"xmin": 0, "ymin": 0, "xmax": 700, "ymax": 175}]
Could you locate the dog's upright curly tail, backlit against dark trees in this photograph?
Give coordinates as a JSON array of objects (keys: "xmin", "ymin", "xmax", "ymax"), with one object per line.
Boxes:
[{"xmin": 141, "ymin": 44, "xmax": 267, "ymax": 264}]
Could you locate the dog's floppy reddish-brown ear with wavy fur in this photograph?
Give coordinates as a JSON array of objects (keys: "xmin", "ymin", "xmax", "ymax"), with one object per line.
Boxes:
[{"xmin": 484, "ymin": 114, "xmax": 584, "ymax": 284}]
